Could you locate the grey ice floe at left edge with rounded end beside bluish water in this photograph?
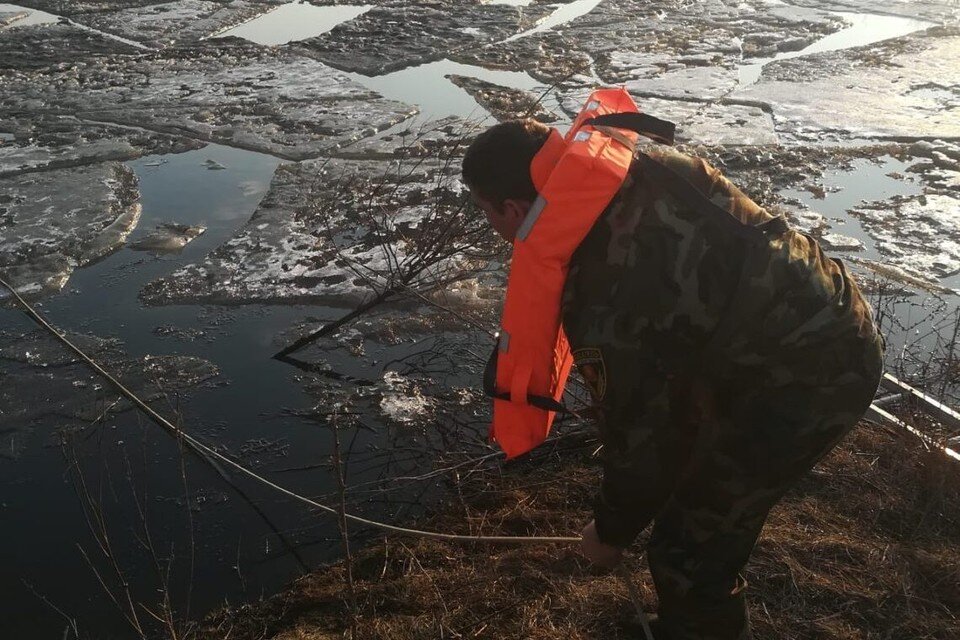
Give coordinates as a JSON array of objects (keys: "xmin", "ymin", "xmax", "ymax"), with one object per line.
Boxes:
[{"xmin": 0, "ymin": 163, "xmax": 140, "ymax": 295}]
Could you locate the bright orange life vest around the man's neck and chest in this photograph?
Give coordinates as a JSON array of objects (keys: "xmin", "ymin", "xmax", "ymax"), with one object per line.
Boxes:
[{"xmin": 485, "ymin": 89, "xmax": 673, "ymax": 458}]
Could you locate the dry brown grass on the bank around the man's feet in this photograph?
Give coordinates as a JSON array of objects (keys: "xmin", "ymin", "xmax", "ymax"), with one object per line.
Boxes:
[{"xmin": 201, "ymin": 424, "xmax": 960, "ymax": 640}]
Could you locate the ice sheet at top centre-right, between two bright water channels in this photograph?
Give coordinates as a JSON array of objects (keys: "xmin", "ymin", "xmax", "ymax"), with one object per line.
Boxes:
[{"xmin": 450, "ymin": 0, "xmax": 842, "ymax": 100}]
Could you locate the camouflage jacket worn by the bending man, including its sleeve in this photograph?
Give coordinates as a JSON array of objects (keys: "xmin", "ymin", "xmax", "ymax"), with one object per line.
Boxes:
[{"xmin": 562, "ymin": 147, "xmax": 879, "ymax": 544}]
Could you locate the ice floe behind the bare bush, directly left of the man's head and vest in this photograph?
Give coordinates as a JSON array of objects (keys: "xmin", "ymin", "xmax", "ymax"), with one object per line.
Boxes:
[{"xmin": 141, "ymin": 158, "xmax": 489, "ymax": 305}]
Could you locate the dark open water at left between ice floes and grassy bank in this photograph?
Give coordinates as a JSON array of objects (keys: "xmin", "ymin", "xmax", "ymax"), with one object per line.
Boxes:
[{"xmin": 0, "ymin": 145, "xmax": 376, "ymax": 638}]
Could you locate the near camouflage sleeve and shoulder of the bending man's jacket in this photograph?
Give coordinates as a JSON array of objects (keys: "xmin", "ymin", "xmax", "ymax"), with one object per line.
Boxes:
[{"xmin": 563, "ymin": 152, "xmax": 771, "ymax": 546}]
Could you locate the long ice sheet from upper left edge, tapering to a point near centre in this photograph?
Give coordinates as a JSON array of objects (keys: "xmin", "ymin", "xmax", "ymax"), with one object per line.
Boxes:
[{"xmin": 0, "ymin": 40, "xmax": 415, "ymax": 160}]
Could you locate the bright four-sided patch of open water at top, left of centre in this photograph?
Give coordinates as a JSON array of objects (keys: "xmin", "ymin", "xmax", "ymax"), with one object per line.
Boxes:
[{"xmin": 217, "ymin": 2, "xmax": 372, "ymax": 45}]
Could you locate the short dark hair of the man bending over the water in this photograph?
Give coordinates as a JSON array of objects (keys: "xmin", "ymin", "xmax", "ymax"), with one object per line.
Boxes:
[{"xmin": 463, "ymin": 118, "xmax": 550, "ymax": 209}]
